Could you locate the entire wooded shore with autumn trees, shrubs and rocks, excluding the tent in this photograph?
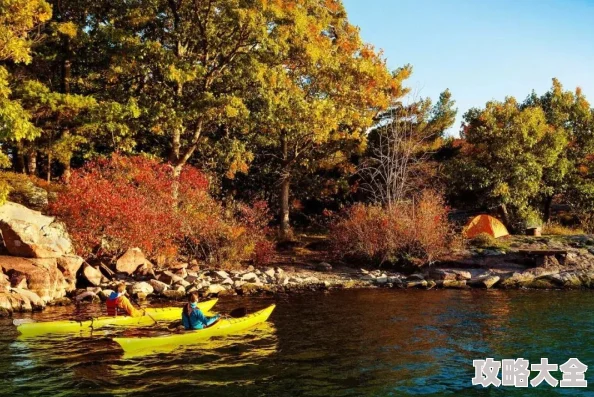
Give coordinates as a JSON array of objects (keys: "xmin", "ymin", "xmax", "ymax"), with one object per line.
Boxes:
[{"xmin": 0, "ymin": 0, "xmax": 594, "ymax": 315}]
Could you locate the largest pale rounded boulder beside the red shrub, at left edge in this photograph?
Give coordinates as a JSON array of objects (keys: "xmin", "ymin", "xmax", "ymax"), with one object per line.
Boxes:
[{"xmin": 0, "ymin": 202, "xmax": 72, "ymax": 258}]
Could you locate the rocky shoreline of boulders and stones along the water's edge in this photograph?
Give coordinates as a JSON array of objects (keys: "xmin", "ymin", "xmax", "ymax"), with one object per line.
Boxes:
[{"xmin": 0, "ymin": 202, "xmax": 594, "ymax": 316}]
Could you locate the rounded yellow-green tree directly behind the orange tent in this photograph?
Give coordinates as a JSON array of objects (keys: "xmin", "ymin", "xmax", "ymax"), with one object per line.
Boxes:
[{"xmin": 447, "ymin": 98, "xmax": 568, "ymax": 228}]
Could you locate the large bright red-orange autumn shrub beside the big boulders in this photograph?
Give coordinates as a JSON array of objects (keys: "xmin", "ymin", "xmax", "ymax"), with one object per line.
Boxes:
[{"xmin": 51, "ymin": 154, "xmax": 267, "ymax": 265}]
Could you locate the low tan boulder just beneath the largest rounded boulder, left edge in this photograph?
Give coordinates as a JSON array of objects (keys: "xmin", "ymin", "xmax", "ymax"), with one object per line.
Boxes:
[{"xmin": 0, "ymin": 256, "xmax": 67, "ymax": 303}]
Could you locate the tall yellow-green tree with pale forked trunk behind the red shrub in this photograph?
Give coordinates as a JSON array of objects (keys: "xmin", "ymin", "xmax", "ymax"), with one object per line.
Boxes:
[{"xmin": 78, "ymin": 0, "xmax": 277, "ymax": 198}]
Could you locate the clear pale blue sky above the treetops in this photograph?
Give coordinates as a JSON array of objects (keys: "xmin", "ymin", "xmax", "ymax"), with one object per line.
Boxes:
[{"xmin": 343, "ymin": 0, "xmax": 594, "ymax": 135}]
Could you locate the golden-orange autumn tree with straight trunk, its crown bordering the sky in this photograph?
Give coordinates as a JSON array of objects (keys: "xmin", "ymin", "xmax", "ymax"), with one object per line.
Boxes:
[{"xmin": 247, "ymin": 0, "xmax": 410, "ymax": 237}]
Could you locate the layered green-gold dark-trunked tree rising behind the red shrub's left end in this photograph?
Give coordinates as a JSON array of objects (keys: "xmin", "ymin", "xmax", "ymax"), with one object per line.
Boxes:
[{"xmin": 6, "ymin": 0, "xmax": 138, "ymax": 181}]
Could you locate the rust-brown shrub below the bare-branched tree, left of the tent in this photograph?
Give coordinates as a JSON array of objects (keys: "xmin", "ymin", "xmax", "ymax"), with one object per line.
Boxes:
[{"xmin": 330, "ymin": 191, "xmax": 454, "ymax": 265}]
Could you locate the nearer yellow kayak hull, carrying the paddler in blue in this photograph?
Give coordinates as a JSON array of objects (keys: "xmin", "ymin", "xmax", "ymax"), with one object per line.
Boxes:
[{"xmin": 113, "ymin": 305, "xmax": 276, "ymax": 353}]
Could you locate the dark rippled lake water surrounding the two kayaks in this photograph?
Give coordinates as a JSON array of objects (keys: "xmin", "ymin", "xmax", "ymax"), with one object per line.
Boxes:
[{"xmin": 0, "ymin": 290, "xmax": 594, "ymax": 396}]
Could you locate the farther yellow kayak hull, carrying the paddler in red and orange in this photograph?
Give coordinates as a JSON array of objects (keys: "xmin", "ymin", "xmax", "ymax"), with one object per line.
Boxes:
[{"xmin": 17, "ymin": 299, "xmax": 217, "ymax": 337}]
